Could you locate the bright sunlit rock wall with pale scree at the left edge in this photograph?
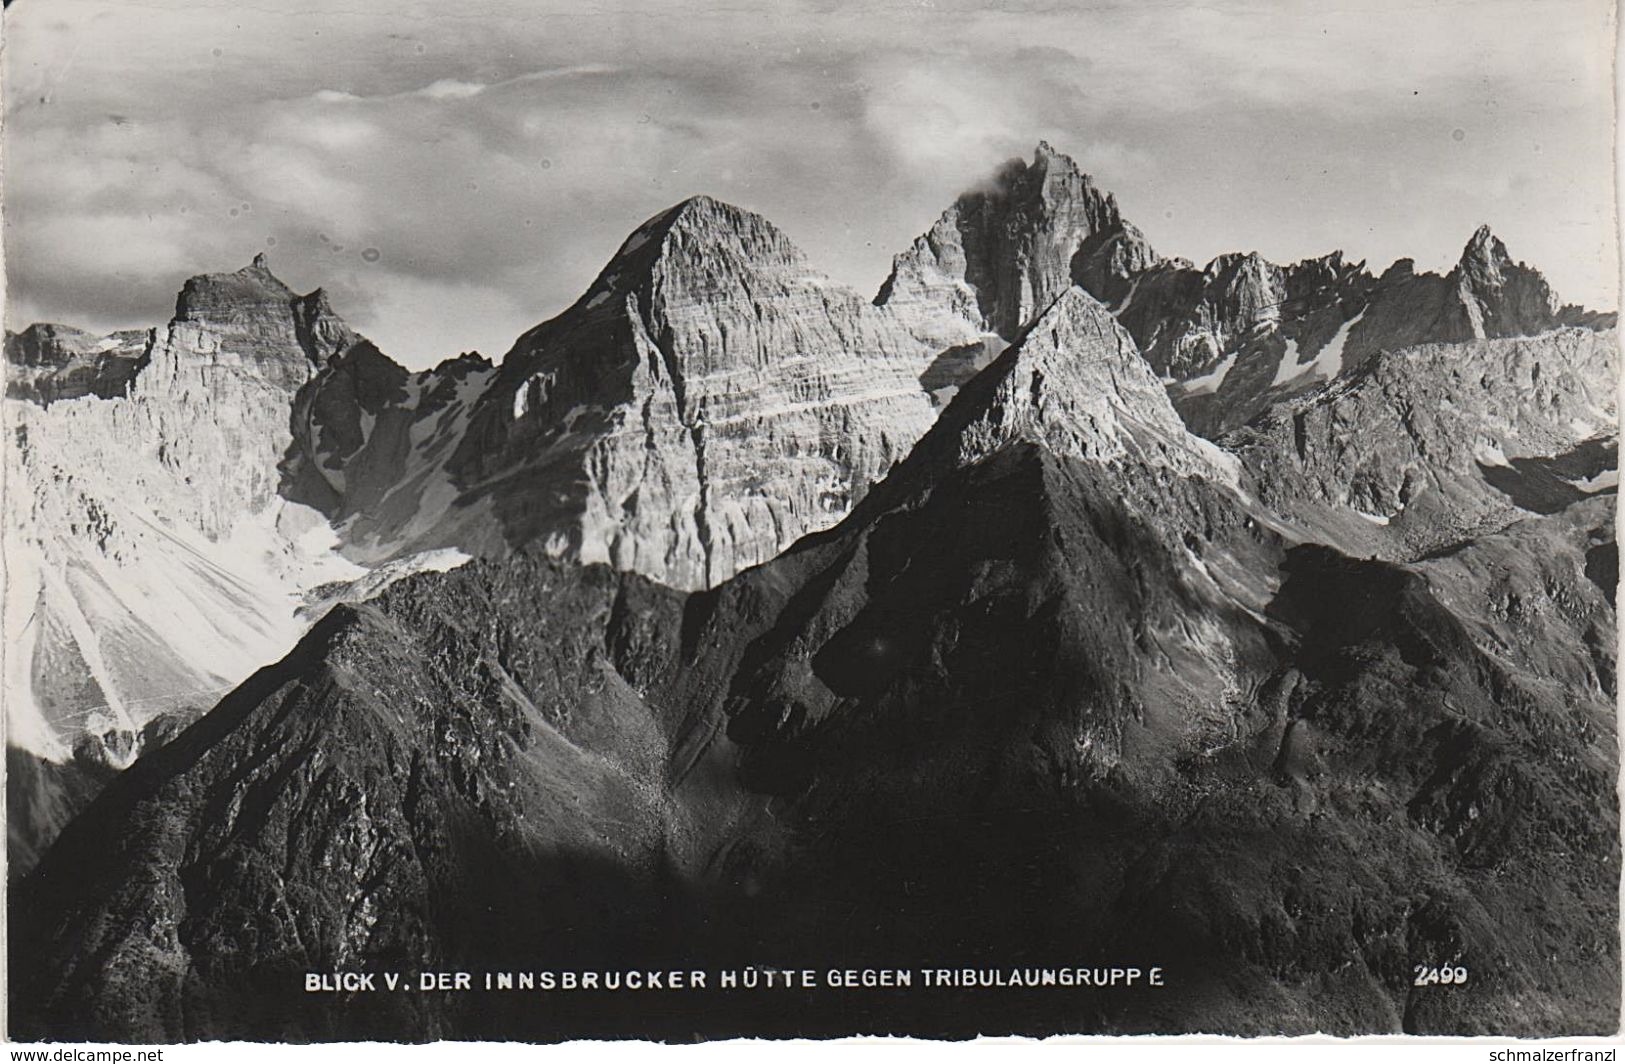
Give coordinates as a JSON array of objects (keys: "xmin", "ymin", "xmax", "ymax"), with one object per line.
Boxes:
[{"xmin": 5, "ymin": 258, "xmax": 359, "ymax": 759}]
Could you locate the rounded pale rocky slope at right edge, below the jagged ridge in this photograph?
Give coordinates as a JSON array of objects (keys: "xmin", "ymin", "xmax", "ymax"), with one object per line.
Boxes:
[{"xmin": 1220, "ymin": 328, "xmax": 1619, "ymax": 560}]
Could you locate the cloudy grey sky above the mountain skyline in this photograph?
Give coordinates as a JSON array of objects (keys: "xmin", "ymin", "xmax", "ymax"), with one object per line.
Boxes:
[{"xmin": 0, "ymin": 0, "xmax": 1619, "ymax": 369}]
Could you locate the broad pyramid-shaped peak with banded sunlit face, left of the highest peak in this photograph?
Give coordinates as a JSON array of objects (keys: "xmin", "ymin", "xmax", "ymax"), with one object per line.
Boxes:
[{"xmin": 455, "ymin": 197, "xmax": 933, "ymax": 590}]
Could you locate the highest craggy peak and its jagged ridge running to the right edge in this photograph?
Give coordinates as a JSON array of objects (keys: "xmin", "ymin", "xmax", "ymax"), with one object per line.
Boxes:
[{"xmin": 876, "ymin": 145, "xmax": 1614, "ymax": 437}]
